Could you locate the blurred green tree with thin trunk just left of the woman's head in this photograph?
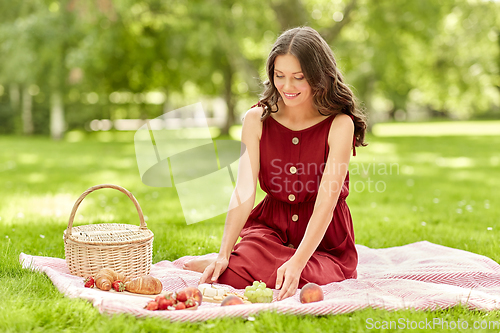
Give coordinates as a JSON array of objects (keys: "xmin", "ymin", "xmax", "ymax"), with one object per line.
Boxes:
[{"xmin": 179, "ymin": 0, "xmax": 277, "ymax": 134}]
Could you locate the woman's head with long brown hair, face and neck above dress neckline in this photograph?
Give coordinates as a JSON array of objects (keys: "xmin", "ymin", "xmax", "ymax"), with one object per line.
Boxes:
[{"xmin": 260, "ymin": 27, "xmax": 366, "ymax": 138}]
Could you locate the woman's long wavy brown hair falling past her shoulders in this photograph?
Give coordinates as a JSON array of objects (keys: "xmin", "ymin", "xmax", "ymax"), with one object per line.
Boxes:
[{"xmin": 260, "ymin": 27, "xmax": 367, "ymax": 147}]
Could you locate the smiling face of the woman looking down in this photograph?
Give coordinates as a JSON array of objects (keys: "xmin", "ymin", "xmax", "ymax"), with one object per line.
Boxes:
[{"xmin": 274, "ymin": 54, "xmax": 313, "ymax": 107}]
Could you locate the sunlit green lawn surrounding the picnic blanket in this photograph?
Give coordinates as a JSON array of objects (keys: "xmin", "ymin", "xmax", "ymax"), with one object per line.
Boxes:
[{"xmin": 0, "ymin": 122, "xmax": 500, "ymax": 332}]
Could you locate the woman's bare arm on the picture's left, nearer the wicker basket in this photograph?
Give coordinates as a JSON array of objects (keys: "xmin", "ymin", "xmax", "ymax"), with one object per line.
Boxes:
[{"xmin": 200, "ymin": 107, "xmax": 262, "ymax": 283}]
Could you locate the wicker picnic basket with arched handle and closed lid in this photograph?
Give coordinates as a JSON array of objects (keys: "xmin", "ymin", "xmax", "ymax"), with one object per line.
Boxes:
[{"xmin": 64, "ymin": 184, "xmax": 154, "ymax": 278}]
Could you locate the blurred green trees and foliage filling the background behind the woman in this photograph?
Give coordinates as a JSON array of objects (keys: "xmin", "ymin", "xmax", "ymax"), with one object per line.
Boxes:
[{"xmin": 0, "ymin": 0, "xmax": 500, "ymax": 133}]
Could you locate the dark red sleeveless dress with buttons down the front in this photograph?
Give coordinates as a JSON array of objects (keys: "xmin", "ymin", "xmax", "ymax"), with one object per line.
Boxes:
[{"xmin": 218, "ymin": 110, "xmax": 358, "ymax": 289}]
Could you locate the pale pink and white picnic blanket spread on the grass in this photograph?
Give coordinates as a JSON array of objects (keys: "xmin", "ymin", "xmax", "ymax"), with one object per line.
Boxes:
[{"xmin": 19, "ymin": 241, "xmax": 500, "ymax": 321}]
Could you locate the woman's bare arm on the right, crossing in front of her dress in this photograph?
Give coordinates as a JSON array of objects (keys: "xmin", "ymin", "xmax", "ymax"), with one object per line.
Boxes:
[{"xmin": 276, "ymin": 114, "xmax": 354, "ymax": 300}]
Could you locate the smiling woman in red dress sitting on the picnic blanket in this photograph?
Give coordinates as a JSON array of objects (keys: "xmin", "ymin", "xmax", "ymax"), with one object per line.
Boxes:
[{"xmin": 185, "ymin": 27, "xmax": 366, "ymax": 300}]
